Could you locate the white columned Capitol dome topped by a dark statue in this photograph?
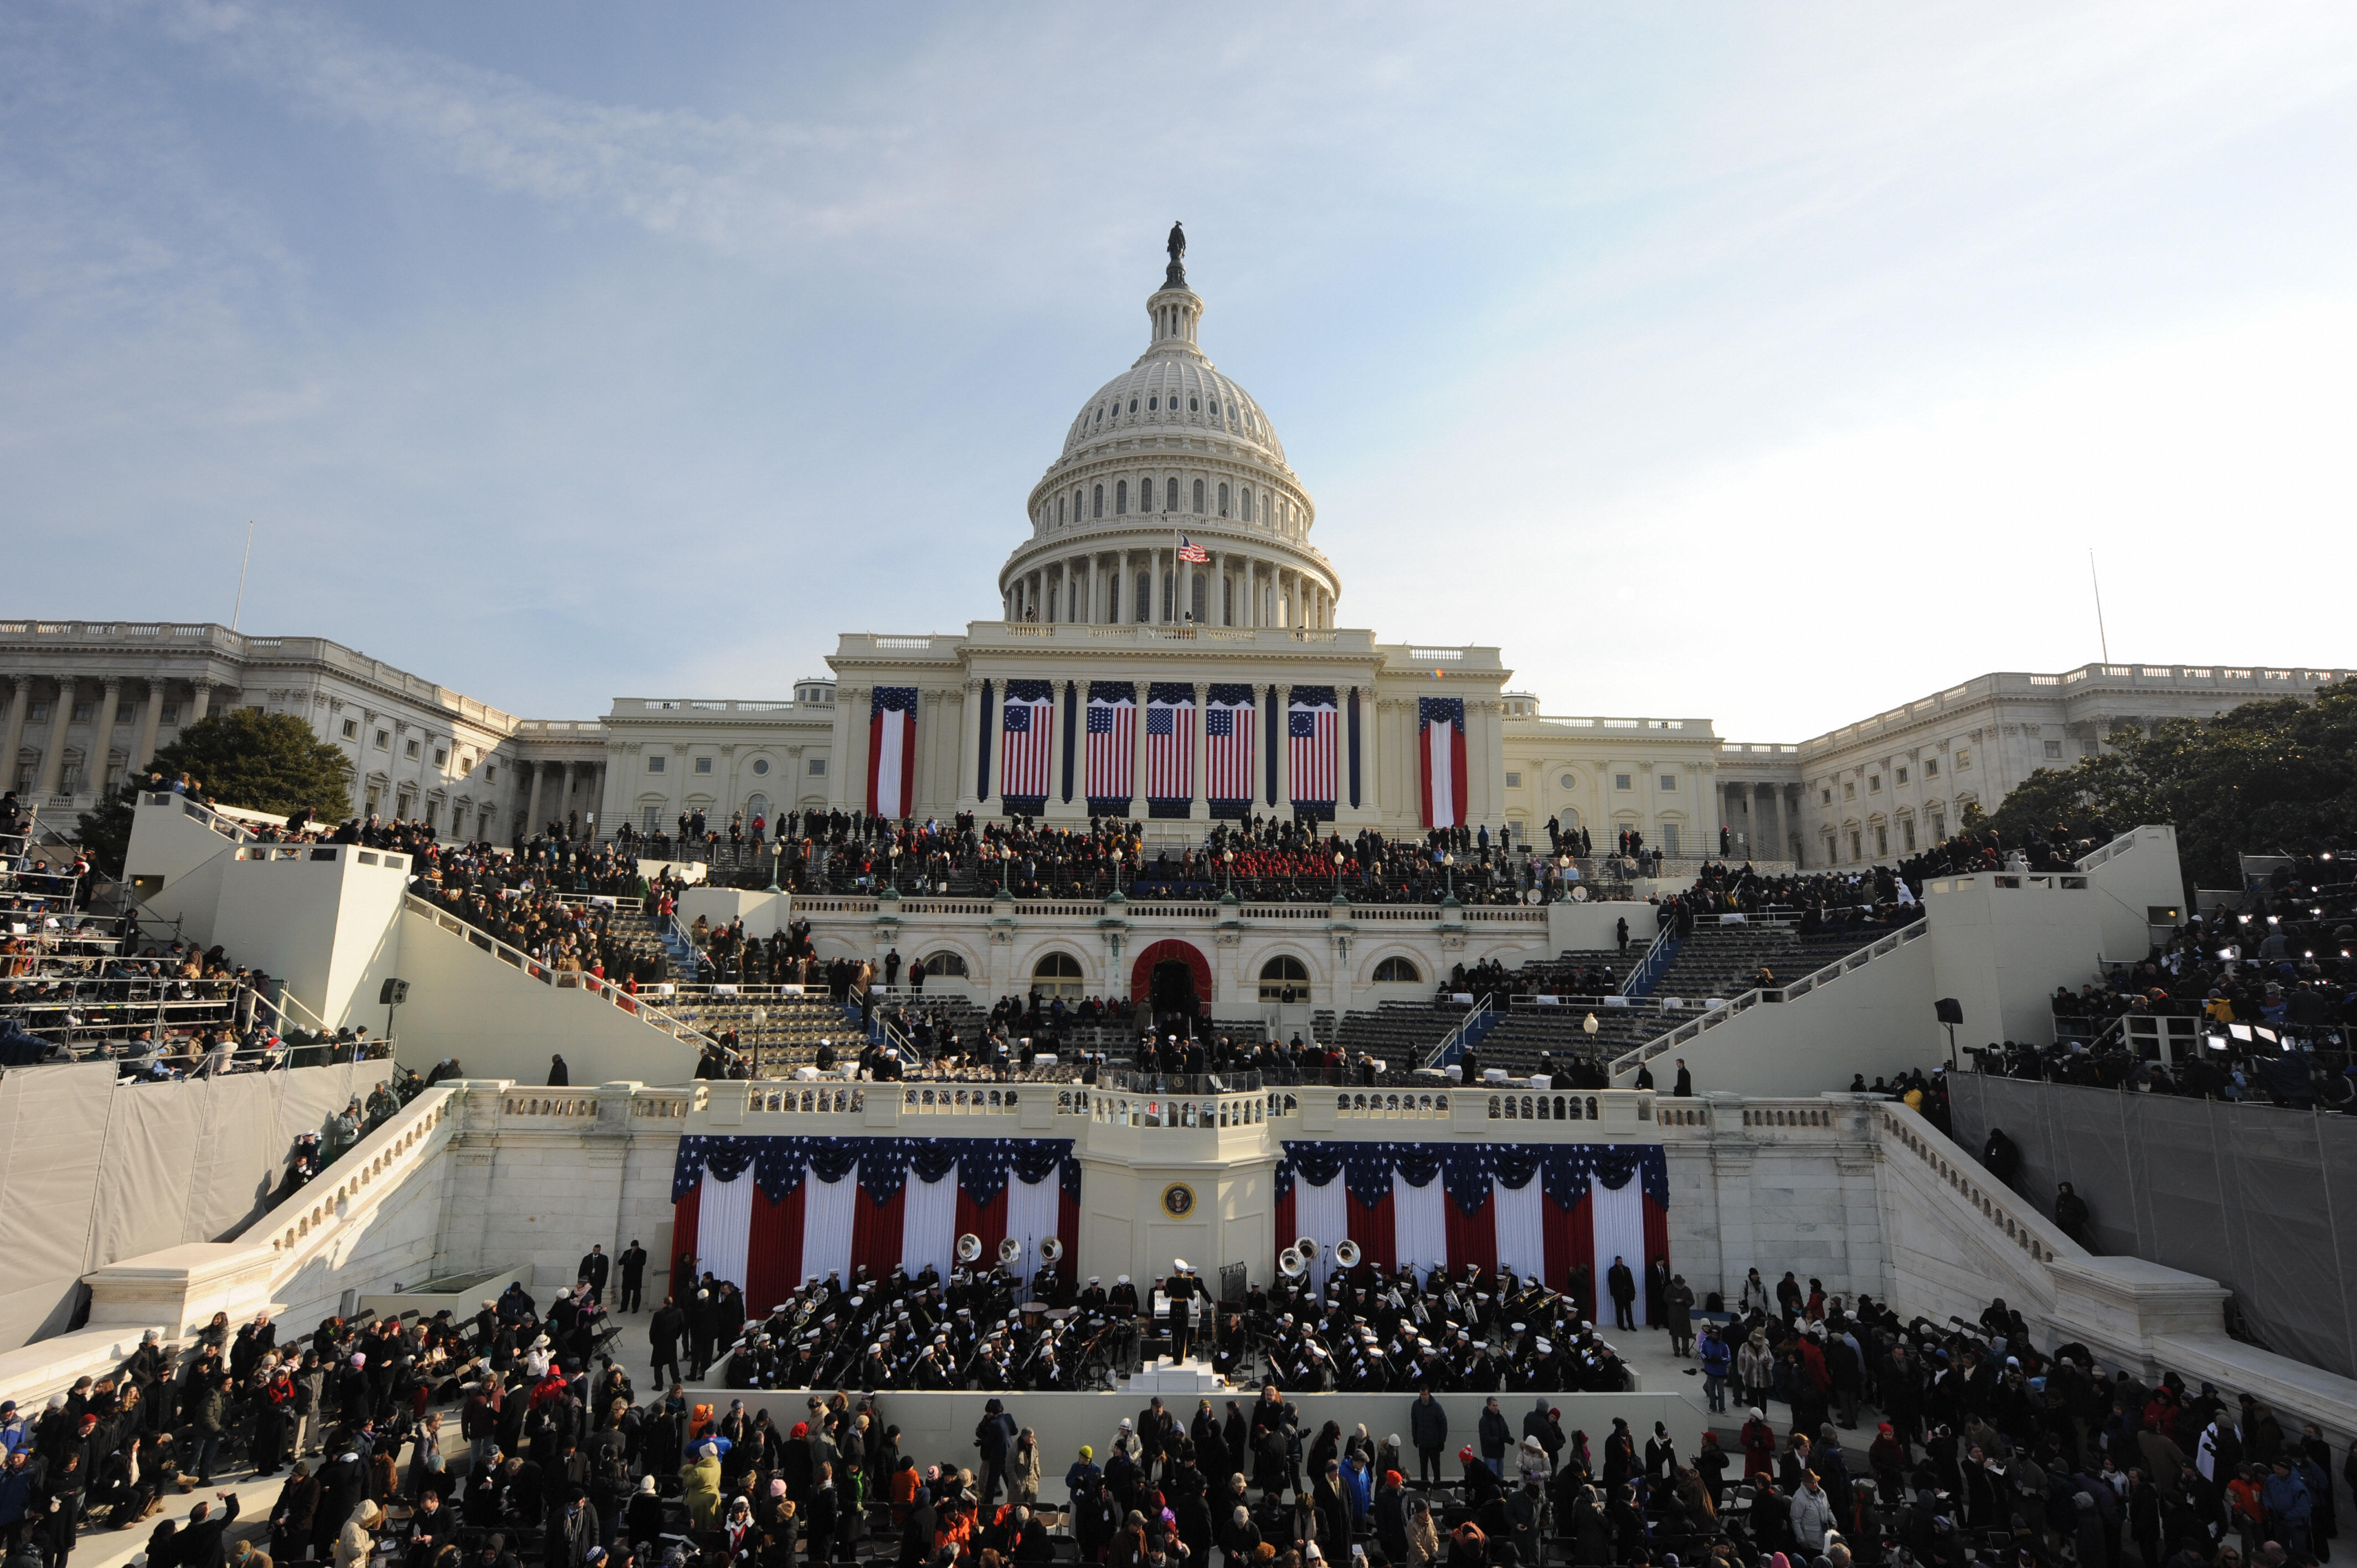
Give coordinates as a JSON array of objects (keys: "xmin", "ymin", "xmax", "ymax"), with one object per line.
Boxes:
[{"xmin": 1000, "ymin": 247, "xmax": 1341, "ymax": 627}]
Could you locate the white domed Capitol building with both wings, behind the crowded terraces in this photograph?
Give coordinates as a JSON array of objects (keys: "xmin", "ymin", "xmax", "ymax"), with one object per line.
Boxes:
[{"xmin": 0, "ymin": 240, "xmax": 2348, "ymax": 870}]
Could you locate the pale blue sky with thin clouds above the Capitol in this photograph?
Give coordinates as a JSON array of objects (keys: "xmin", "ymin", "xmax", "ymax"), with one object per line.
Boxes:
[{"xmin": 0, "ymin": 0, "xmax": 2357, "ymax": 740}]
